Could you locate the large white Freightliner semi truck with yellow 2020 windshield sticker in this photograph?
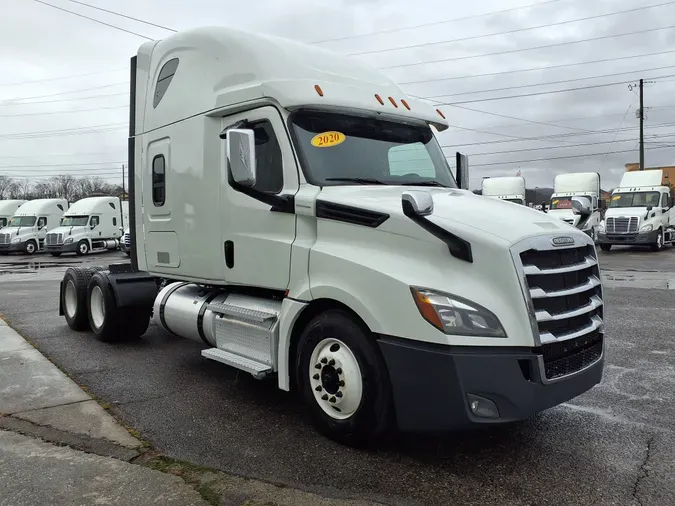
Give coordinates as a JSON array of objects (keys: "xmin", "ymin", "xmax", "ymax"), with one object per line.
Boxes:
[{"xmin": 59, "ymin": 28, "xmax": 605, "ymax": 444}]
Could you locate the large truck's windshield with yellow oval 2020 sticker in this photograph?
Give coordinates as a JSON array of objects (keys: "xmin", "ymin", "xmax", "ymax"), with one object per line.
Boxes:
[{"xmin": 292, "ymin": 111, "xmax": 457, "ymax": 188}]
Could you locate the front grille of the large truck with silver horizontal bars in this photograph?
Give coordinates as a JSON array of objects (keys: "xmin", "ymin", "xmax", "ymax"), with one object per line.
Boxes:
[{"xmin": 514, "ymin": 236, "xmax": 604, "ymax": 379}]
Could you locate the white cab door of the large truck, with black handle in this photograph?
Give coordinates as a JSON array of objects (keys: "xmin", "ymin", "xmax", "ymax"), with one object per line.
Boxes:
[{"xmin": 220, "ymin": 106, "xmax": 298, "ymax": 290}]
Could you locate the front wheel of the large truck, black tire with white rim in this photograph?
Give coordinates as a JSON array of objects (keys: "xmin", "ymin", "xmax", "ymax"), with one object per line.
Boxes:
[{"xmin": 295, "ymin": 310, "xmax": 393, "ymax": 447}]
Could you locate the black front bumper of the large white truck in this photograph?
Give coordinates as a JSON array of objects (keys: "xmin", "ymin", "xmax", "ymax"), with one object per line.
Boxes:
[{"xmin": 378, "ymin": 333, "xmax": 604, "ymax": 432}]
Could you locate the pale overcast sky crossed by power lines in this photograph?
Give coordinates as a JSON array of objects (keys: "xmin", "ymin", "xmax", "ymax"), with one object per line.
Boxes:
[{"xmin": 0, "ymin": 0, "xmax": 675, "ymax": 189}]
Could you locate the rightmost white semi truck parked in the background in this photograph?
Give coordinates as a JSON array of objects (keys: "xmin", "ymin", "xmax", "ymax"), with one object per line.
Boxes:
[{"xmin": 599, "ymin": 169, "xmax": 675, "ymax": 251}]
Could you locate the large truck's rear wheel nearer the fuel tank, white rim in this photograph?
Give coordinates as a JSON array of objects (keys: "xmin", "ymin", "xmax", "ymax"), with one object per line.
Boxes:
[{"xmin": 87, "ymin": 272, "xmax": 123, "ymax": 342}]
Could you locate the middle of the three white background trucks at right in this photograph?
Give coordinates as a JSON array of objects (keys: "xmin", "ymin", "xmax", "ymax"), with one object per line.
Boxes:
[{"xmin": 548, "ymin": 172, "xmax": 604, "ymax": 242}]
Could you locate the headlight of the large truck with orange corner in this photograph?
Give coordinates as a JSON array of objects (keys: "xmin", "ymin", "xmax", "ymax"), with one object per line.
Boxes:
[{"xmin": 410, "ymin": 287, "xmax": 506, "ymax": 337}]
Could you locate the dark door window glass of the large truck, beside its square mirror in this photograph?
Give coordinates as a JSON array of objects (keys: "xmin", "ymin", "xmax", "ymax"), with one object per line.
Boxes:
[{"xmin": 252, "ymin": 121, "xmax": 284, "ymax": 193}]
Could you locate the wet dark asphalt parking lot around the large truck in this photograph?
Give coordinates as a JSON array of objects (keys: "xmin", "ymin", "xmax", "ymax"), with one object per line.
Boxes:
[{"xmin": 0, "ymin": 248, "xmax": 675, "ymax": 506}]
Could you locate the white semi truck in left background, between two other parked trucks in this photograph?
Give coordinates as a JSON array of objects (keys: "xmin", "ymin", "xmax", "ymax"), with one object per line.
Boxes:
[{"xmin": 0, "ymin": 199, "xmax": 68, "ymax": 255}]
